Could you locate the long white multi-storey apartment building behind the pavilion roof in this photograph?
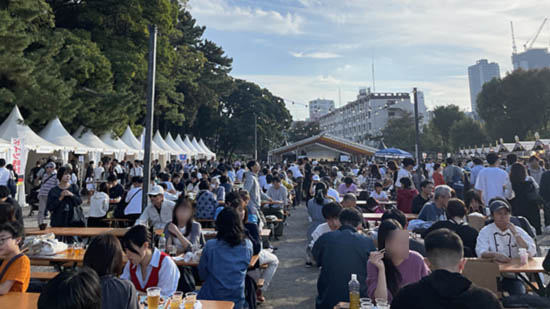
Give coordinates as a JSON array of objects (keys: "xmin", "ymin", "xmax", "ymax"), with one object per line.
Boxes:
[{"xmin": 319, "ymin": 88, "xmax": 429, "ymax": 143}]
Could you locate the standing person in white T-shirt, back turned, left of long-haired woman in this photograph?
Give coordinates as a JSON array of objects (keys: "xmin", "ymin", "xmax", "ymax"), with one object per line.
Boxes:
[{"xmin": 475, "ymin": 152, "xmax": 514, "ymax": 205}]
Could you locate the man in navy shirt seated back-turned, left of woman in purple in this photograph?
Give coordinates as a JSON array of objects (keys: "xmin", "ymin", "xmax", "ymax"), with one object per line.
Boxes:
[{"xmin": 311, "ymin": 208, "xmax": 375, "ymax": 309}]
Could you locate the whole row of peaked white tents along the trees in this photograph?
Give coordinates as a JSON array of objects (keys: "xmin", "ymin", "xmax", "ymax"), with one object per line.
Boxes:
[{"xmin": 0, "ymin": 106, "xmax": 216, "ymax": 166}]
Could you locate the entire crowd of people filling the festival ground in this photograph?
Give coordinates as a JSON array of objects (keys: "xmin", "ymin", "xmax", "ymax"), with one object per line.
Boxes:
[{"xmin": 0, "ymin": 153, "xmax": 550, "ymax": 308}]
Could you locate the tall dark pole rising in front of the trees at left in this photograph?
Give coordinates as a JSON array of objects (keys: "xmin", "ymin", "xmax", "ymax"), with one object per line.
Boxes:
[{"xmin": 141, "ymin": 25, "xmax": 157, "ymax": 209}]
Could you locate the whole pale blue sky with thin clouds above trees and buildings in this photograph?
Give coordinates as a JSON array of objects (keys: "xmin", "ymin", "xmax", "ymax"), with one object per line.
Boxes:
[{"xmin": 189, "ymin": 0, "xmax": 550, "ymax": 119}]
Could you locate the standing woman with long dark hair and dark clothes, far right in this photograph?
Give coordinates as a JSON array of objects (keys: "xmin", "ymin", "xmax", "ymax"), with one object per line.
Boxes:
[{"xmin": 510, "ymin": 163, "xmax": 544, "ymax": 235}]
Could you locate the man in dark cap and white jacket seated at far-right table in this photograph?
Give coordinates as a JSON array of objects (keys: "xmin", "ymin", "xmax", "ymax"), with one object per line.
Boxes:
[{"xmin": 476, "ymin": 198, "xmax": 537, "ymax": 295}]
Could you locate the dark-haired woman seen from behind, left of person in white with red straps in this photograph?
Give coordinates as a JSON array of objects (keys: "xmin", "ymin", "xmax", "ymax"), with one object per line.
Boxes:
[{"xmin": 83, "ymin": 234, "xmax": 139, "ymax": 309}]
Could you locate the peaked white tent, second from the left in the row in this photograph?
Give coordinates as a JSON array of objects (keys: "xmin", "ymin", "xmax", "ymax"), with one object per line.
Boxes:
[{"xmin": 39, "ymin": 117, "xmax": 97, "ymax": 163}]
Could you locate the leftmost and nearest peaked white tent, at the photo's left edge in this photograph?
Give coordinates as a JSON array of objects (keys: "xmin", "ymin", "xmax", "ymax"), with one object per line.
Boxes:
[{"xmin": 0, "ymin": 106, "xmax": 62, "ymax": 153}]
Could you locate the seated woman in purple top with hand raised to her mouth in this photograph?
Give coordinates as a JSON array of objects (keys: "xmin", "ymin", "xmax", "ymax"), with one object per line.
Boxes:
[{"xmin": 367, "ymin": 219, "xmax": 429, "ymax": 302}]
